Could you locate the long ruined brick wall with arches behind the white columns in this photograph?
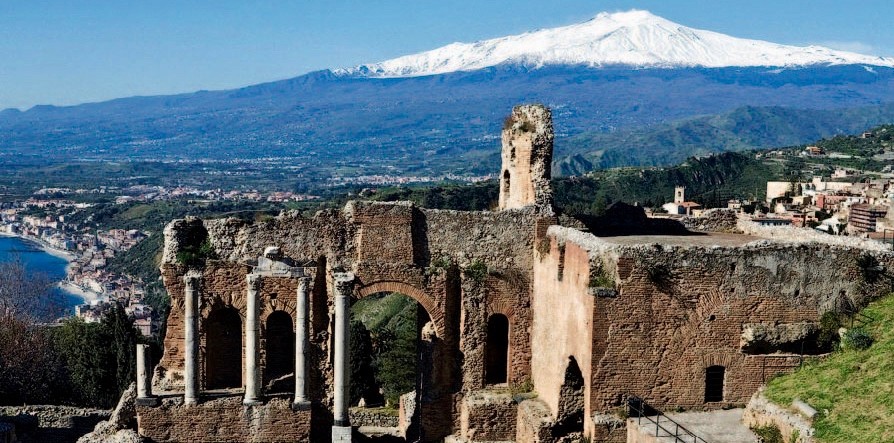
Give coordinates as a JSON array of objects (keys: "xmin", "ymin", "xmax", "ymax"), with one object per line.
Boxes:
[{"xmin": 153, "ymin": 202, "xmax": 552, "ymax": 443}]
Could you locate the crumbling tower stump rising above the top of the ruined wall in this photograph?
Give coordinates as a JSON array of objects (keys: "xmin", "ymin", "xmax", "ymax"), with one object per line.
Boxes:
[{"xmin": 500, "ymin": 105, "xmax": 553, "ymax": 212}]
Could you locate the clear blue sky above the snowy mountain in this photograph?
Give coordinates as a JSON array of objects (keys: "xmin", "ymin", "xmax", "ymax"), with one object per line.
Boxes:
[{"xmin": 0, "ymin": 0, "xmax": 894, "ymax": 109}]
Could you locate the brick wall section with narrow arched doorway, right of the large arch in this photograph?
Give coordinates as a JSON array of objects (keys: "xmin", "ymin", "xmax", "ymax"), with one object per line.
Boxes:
[{"xmin": 423, "ymin": 210, "xmax": 543, "ymax": 390}]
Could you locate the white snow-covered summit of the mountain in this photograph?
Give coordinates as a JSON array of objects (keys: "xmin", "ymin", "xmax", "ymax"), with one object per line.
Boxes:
[{"xmin": 333, "ymin": 10, "xmax": 894, "ymax": 77}]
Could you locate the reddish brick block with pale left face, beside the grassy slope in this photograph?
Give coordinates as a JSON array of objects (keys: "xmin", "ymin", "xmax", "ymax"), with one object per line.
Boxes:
[{"xmin": 532, "ymin": 227, "xmax": 892, "ymax": 430}]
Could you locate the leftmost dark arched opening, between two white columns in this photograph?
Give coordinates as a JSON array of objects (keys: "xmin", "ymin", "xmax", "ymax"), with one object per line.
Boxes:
[{"xmin": 205, "ymin": 308, "xmax": 242, "ymax": 389}]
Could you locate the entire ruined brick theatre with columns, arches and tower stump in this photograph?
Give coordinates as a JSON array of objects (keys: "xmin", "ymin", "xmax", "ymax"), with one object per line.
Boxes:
[{"xmin": 137, "ymin": 106, "xmax": 892, "ymax": 442}]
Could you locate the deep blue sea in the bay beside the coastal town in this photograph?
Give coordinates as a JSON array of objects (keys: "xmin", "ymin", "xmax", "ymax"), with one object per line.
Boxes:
[{"xmin": 0, "ymin": 237, "xmax": 84, "ymax": 314}]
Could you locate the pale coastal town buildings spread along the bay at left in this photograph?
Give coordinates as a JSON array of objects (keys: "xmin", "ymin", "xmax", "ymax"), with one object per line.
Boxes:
[{"xmin": 0, "ymin": 185, "xmax": 324, "ymax": 336}]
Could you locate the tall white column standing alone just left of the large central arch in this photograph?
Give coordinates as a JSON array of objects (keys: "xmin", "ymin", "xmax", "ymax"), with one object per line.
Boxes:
[{"xmin": 332, "ymin": 272, "xmax": 354, "ymax": 443}]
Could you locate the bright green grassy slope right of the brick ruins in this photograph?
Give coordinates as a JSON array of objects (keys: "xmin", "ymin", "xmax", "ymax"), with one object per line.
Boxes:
[{"xmin": 766, "ymin": 294, "xmax": 894, "ymax": 443}]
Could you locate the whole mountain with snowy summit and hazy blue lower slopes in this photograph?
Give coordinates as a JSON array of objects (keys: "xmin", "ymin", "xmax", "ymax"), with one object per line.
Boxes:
[{"xmin": 0, "ymin": 11, "xmax": 894, "ymax": 174}]
